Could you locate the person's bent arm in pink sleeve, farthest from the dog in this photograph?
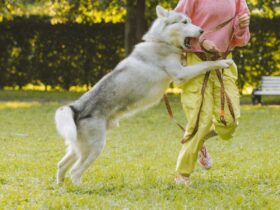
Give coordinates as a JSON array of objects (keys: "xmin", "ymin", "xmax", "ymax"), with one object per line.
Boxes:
[{"xmin": 231, "ymin": 0, "xmax": 250, "ymax": 48}]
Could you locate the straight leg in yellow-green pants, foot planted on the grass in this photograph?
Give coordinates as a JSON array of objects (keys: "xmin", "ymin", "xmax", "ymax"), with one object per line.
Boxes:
[{"xmin": 176, "ymin": 54, "xmax": 213, "ymax": 180}]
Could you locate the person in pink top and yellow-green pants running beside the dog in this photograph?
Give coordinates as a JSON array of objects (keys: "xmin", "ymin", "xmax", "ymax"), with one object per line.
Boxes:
[{"xmin": 175, "ymin": 0, "xmax": 250, "ymax": 185}]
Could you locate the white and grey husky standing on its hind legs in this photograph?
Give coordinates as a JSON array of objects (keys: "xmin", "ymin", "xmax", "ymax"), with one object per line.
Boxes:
[{"xmin": 55, "ymin": 6, "xmax": 233, "ymax": 185}]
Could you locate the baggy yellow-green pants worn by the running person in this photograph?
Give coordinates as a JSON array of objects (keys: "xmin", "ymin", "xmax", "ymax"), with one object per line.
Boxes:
[{"xmin": 176, "ymin": 53, "xmax": 240, "ymax": 176}]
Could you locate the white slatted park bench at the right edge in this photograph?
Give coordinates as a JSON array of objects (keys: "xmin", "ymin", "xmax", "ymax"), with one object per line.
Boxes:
[{"xmin": 252, "ymin": 76, "xmax": 280, "ymax": 104}]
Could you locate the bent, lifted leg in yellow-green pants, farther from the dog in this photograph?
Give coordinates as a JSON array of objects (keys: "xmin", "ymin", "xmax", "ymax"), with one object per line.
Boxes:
[{"xmin": 214, "ymin": 56, "xmax": 240, "ymax": 140}]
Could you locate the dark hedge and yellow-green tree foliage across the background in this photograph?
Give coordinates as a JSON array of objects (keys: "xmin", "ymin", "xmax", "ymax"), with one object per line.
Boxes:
[{"xmin": 0, "ymin": 0, "xmax": 280, "ymax": 89}]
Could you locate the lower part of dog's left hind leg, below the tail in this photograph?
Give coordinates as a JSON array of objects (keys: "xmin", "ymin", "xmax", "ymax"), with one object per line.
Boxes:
[{"xmin": 57, "ymin": 146, "xmax": 77, "ymax": 184}]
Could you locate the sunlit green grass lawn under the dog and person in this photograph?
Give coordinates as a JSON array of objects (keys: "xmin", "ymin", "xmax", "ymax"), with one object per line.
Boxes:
[{"xmin": 0, "ymin": 92, "xmax": 280, "ymax": 209}]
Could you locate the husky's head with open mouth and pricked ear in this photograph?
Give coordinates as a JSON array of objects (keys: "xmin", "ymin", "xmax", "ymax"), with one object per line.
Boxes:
[{"xmin": 143, "ymin": 5, "xmax": 203, "ymax": 49}]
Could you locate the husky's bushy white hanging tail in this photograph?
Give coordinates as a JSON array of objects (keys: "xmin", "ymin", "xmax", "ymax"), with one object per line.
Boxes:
[{"xmin": 55, "ymin": 106, "xmax": 77, "ymax": 145}]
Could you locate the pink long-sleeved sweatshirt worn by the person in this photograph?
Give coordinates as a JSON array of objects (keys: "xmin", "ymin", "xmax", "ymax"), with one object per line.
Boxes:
[{"xmin": 175, "ymin": 0, "xmax": 250, "ymax": 52}]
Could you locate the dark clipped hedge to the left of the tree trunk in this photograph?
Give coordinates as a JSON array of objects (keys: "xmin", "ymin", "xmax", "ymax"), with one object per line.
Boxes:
[{"xmin": 0, "ymin": 16, "xmax": 124, "ymax": 89}]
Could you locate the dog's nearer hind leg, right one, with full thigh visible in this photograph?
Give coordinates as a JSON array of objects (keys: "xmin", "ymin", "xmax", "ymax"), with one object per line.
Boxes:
[{"xmin": 70, "ymin": 119, "xmax": 106, "ymax": 185}]
